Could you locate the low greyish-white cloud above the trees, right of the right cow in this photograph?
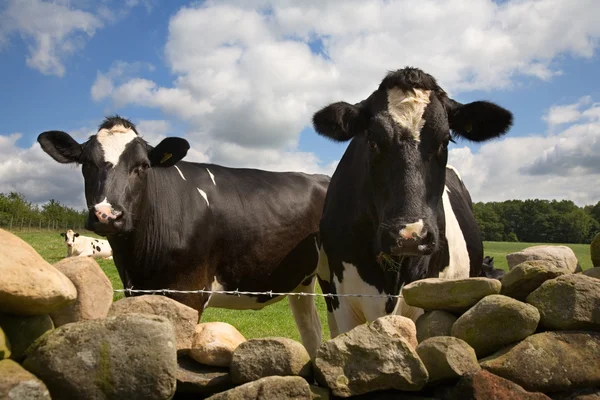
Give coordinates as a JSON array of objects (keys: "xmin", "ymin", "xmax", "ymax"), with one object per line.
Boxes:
[{"xmin": 449, "ymin": 97, "xmax": 600, "ymax": 205}]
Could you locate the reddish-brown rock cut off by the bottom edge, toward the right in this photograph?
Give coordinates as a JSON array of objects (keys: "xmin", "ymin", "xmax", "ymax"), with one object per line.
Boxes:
[{"xmin": 444, "ymin": 370, "xmax": 550, "ymax": 400}]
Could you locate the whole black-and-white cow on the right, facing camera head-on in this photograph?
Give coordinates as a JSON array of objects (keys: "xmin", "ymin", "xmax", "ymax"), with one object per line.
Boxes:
[{"xmin": 313, "ymin": 68, "xmax": 512, "ymax": 336}]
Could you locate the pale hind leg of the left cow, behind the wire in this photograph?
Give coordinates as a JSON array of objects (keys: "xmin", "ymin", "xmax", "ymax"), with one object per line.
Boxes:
[{"xmin": 288, "ymin": 276, "xmax": 321, "ymax": 360}]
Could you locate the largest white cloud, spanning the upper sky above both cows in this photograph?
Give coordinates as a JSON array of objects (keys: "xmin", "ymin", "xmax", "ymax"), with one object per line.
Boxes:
[{"xmin": 94, "ymin": 0, "xmax": 600, "ymax": 173}]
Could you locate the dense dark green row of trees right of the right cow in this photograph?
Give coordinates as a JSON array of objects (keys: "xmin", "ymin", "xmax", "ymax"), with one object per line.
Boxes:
[{"xmin": 473, "ymin": 199, "xmax": 600, "ymax": 243}]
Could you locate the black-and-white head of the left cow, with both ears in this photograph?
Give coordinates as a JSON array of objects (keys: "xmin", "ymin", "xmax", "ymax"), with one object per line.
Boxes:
[{"xmin": 38, "ymin": 116, "xmax": 190, "ymax": 235}]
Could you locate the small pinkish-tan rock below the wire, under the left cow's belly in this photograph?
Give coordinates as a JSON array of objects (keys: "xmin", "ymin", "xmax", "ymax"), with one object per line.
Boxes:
[{"xmin": 189, "ymin": 322, "xmax": 246, "ymax": 367}]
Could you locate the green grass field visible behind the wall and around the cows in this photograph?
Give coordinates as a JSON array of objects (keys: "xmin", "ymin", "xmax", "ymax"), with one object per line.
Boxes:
[{"xmin": 15, "ymin": 231, "xmax": 592, "ymax": 340}]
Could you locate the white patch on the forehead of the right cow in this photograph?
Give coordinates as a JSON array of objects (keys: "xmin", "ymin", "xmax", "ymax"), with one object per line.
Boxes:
[{"xmin": 388, "ymin": 88, "xmax": 431, "ymax": 141}]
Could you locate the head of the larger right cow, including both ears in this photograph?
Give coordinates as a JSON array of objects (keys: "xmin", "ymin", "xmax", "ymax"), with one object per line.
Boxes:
[{"xmin": 313, "ymin": 68, "xmax": 512, "ymax": 256}]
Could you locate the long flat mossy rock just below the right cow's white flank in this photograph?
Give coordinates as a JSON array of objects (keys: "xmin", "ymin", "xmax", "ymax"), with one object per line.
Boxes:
[{"xmin": 402, "ymin": 278, "xmax": 501, "ymax": 313}]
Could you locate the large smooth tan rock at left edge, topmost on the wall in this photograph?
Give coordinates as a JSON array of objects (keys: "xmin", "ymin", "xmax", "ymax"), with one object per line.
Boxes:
[{"xmin": 0, "ymin": 229, "xmax": 77, "ymax": 315}]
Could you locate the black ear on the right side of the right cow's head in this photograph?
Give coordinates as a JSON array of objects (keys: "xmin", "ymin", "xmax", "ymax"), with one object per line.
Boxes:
[{"xmin": 446, "ymin": 99, "xmax": 513, "ymax": 142}]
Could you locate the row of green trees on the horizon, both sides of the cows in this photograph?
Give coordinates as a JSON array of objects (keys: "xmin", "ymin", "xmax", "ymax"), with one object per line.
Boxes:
[{"xmin": 0, "ymin": 192, "xmax": 600, "ymax": 243}]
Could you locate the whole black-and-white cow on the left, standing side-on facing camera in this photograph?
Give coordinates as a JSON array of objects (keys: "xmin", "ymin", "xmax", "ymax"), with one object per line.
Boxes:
[{"xmin": 38, "ymin": 115, "xmax": 329, "ymax": 357}]
